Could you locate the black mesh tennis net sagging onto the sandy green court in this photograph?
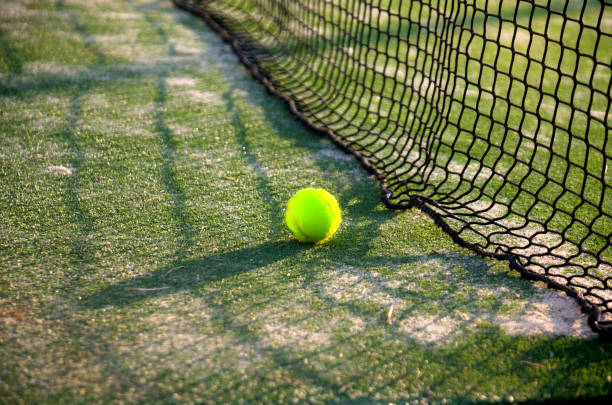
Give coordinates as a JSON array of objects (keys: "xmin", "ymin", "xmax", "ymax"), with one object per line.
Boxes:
[{"xmin": 175, "ymin": 0, "xmax": 612, "ymax": 336}]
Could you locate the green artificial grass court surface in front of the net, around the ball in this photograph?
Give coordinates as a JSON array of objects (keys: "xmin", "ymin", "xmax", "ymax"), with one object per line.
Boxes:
[{"xmin": 0, "ymin": 0, "xmax": 612, "ymax": 404}]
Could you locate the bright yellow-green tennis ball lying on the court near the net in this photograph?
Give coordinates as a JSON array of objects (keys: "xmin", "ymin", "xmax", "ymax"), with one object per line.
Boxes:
[{"xmin": 285, "ymin": 188, "xmax": 341, "ymax": 243}]
